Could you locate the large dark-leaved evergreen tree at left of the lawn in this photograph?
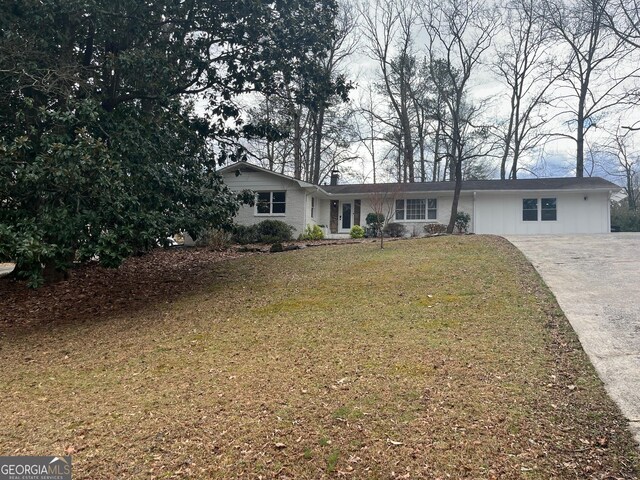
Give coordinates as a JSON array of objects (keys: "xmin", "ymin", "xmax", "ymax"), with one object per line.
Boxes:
[{"xmin": 0, "ymin": 0, "xmax": 336, "ymax": 285}]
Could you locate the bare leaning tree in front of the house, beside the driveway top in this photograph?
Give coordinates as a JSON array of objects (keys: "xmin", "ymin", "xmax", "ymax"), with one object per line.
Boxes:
[{"xmin": 423, "ymin": 0, "xmax": 498, "ymax": 233}]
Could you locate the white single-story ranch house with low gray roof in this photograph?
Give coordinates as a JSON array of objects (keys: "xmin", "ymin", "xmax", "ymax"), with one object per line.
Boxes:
[{"xmin": 220, "ymin": 162, "xmax": 620, "ymax": 238}]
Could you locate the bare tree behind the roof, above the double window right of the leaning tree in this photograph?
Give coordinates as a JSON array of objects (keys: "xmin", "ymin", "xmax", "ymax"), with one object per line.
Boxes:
[{"xmin": 494, "ymin": 0, "xmax": 563, "ymax": 179}]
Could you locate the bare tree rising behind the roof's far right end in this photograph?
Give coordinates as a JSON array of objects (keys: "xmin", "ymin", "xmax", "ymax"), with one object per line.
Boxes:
[{"xmin": 541, "ymin": 0, "xmax": 640, "ymax": 177}]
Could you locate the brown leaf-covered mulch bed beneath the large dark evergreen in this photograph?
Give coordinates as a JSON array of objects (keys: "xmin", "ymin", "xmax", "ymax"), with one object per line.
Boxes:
[{"xmin": 0, "ymin": 240, "xmax": 372, "ymax": 331}]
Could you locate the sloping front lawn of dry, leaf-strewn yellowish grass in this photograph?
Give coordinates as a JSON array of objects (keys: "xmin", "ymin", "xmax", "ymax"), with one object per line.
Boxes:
[{"xmin": 0, "ymin": 236, "xmax": 639, "ymax": 479}]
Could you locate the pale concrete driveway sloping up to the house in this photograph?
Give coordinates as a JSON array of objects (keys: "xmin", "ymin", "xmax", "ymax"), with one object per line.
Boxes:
[{"xmin": 506, "ymin": 233, "xmax": 640, "ymax": 443}]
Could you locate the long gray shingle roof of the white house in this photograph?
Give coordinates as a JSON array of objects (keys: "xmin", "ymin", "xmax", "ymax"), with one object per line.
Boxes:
[{"xmin": 321, "ymin": 177, "xmax": 620, "ymax": 195}]
